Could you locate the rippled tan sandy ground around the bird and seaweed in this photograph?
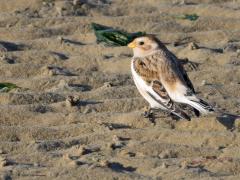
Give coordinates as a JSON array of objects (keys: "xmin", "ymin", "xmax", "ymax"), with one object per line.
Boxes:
[{"xmin": 0, "ymin": 0, "xmax": 240, "ymax": 180}]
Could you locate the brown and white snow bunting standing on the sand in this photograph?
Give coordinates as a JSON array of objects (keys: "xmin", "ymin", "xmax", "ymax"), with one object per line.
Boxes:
[{"xmin": 128, "ymin": 35, "xmax": 213, "ymax": 120}]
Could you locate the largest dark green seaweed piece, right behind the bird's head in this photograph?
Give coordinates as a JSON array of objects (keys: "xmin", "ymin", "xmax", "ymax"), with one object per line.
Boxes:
[{"xmin": 91, "ymin": 23, "xmax": 146, "ymax": 46}]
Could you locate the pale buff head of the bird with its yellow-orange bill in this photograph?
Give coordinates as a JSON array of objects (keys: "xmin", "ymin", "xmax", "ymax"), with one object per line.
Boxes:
[{"xmin": 128, "ymin": 35, "xmax": 161, "ymax": 57}]
